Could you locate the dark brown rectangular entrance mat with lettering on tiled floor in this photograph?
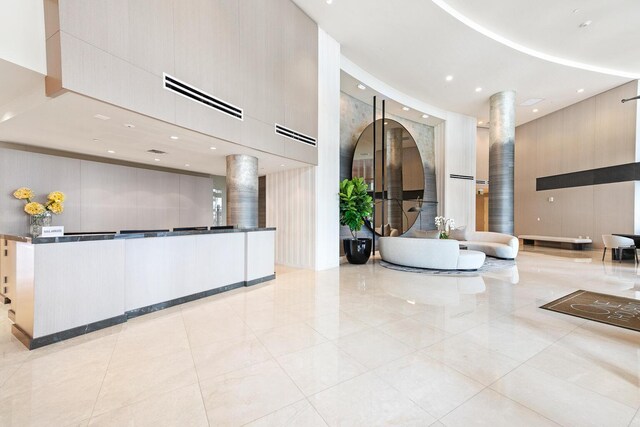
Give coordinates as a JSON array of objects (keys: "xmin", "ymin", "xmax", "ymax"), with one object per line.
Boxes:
[{"xmin": 540, "ymin": 290, "xmax": 640, "ymax": 332}]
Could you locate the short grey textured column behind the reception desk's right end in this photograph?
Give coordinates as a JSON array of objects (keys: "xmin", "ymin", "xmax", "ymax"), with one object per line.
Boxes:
[{"xmin": 227, "ymin": 154, "xmax": 258, "ymax": 228}]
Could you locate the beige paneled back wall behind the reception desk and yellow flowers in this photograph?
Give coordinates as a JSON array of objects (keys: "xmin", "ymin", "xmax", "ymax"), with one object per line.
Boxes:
[{"xmin": 0, "ymin": 148, "xmax": 213, "ymax": 235}]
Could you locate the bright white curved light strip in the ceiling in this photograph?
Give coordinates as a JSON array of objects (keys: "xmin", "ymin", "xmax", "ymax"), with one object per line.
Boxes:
[{"xmin": 431, "ymin": 0, "xmax": 640, "ymax": 80}]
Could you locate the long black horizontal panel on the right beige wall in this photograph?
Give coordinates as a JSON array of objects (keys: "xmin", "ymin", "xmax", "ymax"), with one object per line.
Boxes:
[{"xmin": 536, "ymin": 163, "xmax": 640, "ymax": 191}]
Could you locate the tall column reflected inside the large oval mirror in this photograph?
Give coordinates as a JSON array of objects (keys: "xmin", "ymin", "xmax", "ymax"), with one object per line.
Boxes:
[{"xmin": 385, "ymin": 129, "xmax": 404, "ymax": 234}]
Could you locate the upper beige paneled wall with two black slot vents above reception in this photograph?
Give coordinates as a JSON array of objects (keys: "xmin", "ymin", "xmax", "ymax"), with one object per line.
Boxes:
[{"xmin": 49, "ymin": 0, "xmax": 318, "ymax": 164}]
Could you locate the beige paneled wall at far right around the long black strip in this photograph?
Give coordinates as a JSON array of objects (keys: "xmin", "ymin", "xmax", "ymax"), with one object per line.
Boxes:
[{"xmin": 514, "ymin": 81, "xmax": 640, "ymax": 246}]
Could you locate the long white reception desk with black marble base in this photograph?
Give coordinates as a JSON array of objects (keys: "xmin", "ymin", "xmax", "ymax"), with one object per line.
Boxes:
[{"xmin": 13, "ymin": 228, "xmax": 275, "ymax": 349}]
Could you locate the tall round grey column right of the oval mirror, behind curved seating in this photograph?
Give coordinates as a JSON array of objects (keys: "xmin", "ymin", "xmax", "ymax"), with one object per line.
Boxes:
[{"xmin": 489, "ymin": 90, "xmax": 516, "ymax": 234}]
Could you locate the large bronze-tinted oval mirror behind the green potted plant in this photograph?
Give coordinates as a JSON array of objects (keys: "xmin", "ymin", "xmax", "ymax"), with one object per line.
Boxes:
[{"xmin": 351, "ymin": 119, "xmax": 424, "ymax": 236}]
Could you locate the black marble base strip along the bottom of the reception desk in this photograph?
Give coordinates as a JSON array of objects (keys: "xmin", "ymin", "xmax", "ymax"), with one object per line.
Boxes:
[{"xmin": 11, "ymin": 274, "xmax": 276, "ymax": 350}]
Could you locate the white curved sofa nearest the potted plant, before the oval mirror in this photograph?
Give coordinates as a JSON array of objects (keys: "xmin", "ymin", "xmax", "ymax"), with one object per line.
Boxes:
[{"xmin": 379, "ymin": 237, "xmax": 485, "ymax": 270}]
